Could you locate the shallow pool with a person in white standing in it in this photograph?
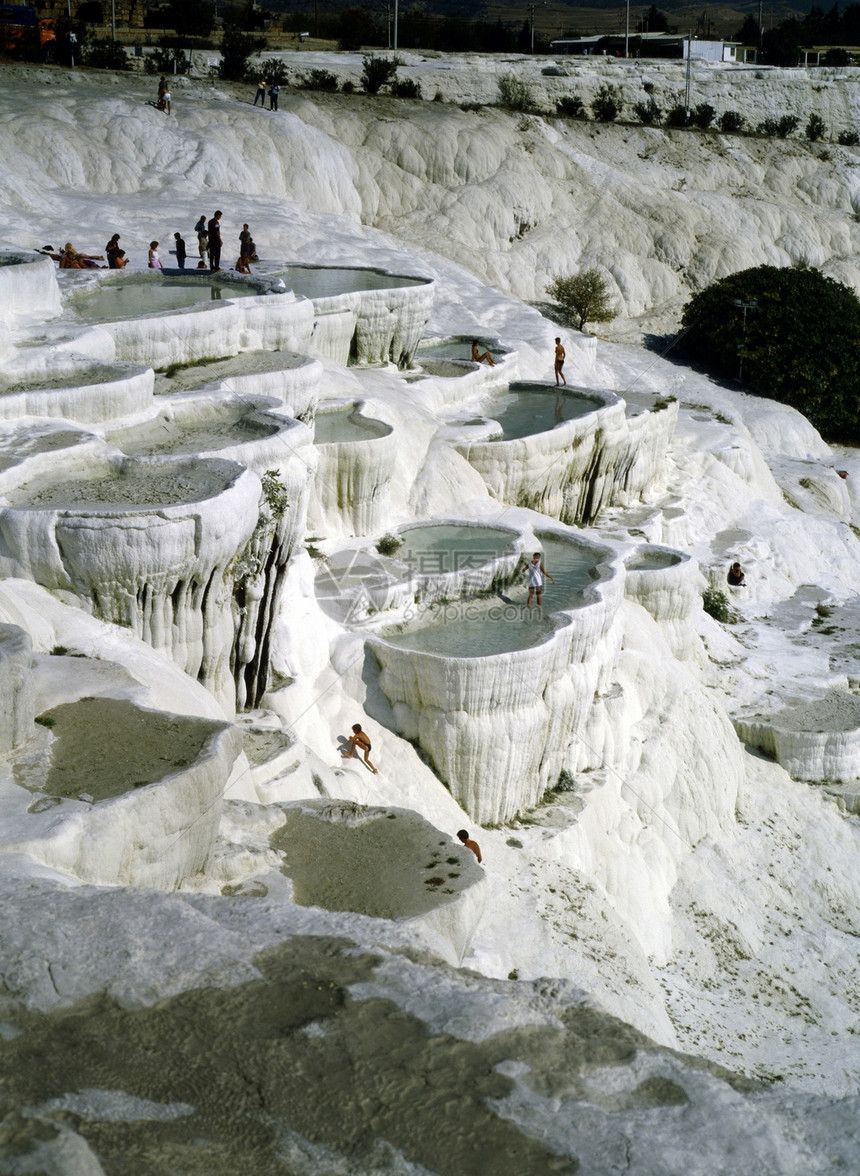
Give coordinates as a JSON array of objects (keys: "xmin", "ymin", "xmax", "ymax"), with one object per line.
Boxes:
[{"xmin": 380, "ymin": 535, "xmax": 599, "ymax": 657}]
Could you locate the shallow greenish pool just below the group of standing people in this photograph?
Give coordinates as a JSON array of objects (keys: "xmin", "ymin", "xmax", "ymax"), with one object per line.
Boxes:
[{"xmin": 66, "ymin": 278, "xmax": 261, "ymax": 322}]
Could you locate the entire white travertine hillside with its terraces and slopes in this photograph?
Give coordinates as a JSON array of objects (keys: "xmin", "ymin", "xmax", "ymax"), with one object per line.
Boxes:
[{"xmin": 0, "ymin": 62, "xmax": 860, "ymax": 1176}]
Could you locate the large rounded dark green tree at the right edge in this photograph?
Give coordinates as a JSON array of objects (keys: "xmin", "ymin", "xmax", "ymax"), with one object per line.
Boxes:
[{"xmin": 680, "ymin": 266, "xmax": 860, "ymax": 445}]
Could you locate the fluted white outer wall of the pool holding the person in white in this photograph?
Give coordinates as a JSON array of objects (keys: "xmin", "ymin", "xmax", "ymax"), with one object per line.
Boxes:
[{"xmin": 367, "ymin": 532, "xmax": 624, "ymax": 824}]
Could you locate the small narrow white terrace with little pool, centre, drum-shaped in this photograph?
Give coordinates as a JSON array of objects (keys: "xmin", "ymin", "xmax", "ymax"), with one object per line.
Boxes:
[{"xmin": 308, "ymin": 403, "xmax": 398, "ymax": 535}]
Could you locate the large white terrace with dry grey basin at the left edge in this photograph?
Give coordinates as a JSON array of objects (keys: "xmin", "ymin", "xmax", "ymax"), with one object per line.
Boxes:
[{"xmin": 0, "ymin": 459, "xmax": 260, "ymax": 708}]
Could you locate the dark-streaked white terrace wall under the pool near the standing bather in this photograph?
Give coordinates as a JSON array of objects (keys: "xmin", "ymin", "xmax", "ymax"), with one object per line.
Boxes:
[{"xmin": 458, "ymin": 385, "xmax": 678, "ymax": 523}]
